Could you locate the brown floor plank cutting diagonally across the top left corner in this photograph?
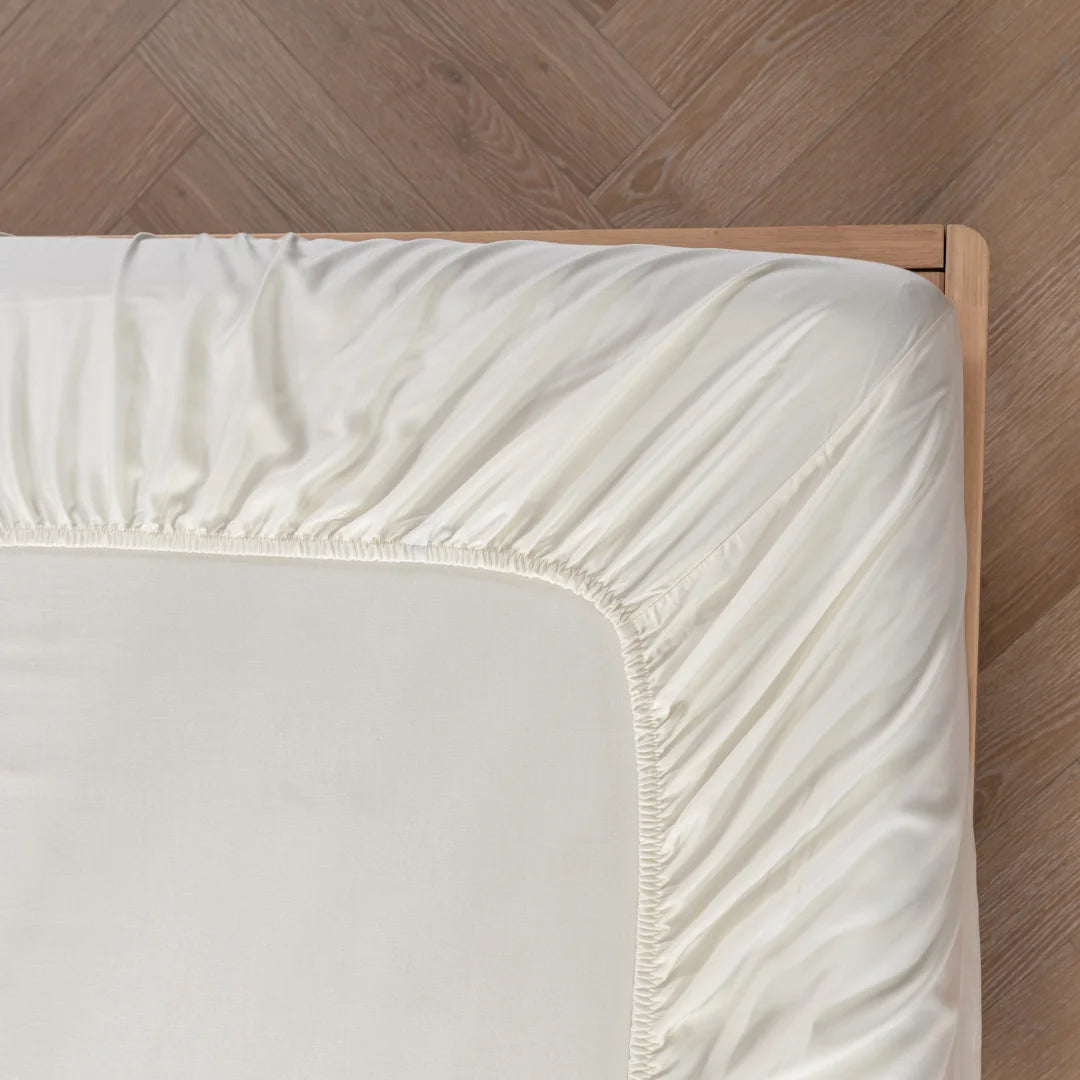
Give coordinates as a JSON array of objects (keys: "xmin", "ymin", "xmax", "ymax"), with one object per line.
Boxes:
[{"xmin": 0, "ymin": 0, "xmax": 174, "ymax": 186}]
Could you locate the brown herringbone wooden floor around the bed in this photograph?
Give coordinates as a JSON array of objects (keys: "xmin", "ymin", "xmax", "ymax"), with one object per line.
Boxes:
[{"xmin": 0, "ymin": 0, "xmax": 1080, "ymax": 1067}]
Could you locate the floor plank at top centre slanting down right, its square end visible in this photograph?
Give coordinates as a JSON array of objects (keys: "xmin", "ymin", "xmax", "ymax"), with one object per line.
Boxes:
[{"xmin": 409, "ymin": 0, "xmax": 671, "ymax": 192}]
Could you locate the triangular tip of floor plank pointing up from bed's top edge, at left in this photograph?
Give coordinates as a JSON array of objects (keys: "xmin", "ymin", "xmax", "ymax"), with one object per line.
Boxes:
[{"xmin": 126, "ymin": 135, "xmax": 289, "ymax": 233}]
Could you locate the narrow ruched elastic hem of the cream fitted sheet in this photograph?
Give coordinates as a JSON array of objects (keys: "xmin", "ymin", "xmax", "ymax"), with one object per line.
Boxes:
[{"xmin": 0, "ymin": 525, "xmax": 665, "ymax": 1080}]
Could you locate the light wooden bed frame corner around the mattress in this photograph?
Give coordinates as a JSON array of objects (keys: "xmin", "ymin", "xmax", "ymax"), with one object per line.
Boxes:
[{"xmin": 257, "ymin": 225, "xmax": 990, "ymax": 761}]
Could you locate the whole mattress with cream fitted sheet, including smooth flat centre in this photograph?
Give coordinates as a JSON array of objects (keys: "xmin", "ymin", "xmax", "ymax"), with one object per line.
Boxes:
[{"xmin": 0, "ymin": 237, "xmax": 980, "ymax": 1080}]
